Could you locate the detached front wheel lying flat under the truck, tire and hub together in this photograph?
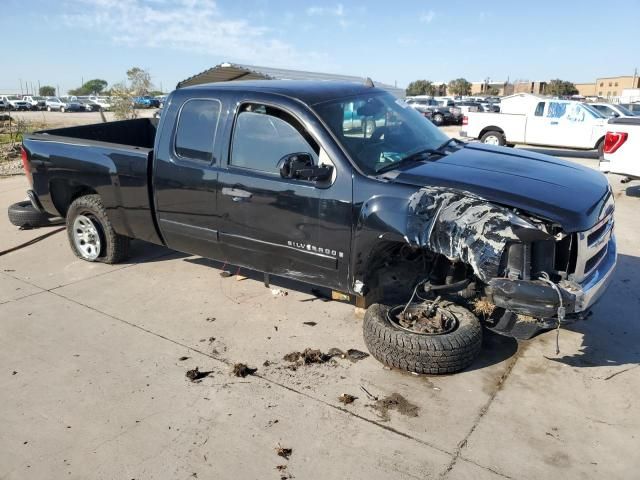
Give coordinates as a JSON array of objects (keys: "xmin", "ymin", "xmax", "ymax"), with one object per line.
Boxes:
[{"xmin": 363, "ymin": 301, "xmax": 482, "ymax": 374}]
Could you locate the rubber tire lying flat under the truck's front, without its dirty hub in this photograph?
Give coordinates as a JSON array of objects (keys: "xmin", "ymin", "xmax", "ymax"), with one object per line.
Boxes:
[{"xmin": 363, "ymin": 302, "xmax": 482, "ymax": 374}]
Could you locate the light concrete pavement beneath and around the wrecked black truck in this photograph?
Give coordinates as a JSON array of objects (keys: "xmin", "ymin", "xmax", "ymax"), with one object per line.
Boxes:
[{"xmin": 0, "ymin": 159, "xmax": 640, "ymax": 479}]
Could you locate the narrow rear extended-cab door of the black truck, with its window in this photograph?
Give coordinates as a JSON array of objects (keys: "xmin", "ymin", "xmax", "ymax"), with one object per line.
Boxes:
[{"xmin": 153, "ymin": 92, "xmax": 227, "ymax": 258}]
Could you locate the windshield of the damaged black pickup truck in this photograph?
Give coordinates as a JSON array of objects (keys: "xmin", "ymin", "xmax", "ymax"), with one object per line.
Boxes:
[{"xmin": 315, "ymin": 92, "xmax": 449, "ymax": 174}]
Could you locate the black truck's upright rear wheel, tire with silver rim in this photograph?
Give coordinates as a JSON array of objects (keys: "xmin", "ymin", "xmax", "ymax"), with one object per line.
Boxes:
[{"xmin": 67, "ymin": 195, "xmax": 130, "ymax": 264}]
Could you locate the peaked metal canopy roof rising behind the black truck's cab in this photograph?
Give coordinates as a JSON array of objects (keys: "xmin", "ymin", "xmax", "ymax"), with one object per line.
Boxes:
[{"xmin": 176, "ymin": 63, "xmax": 405, "ymax": 98}]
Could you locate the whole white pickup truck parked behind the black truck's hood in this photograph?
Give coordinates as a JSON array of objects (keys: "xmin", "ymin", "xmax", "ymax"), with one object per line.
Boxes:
[{"xmin": 460, "ymin": 97, "xmax": 608, "ymax": 153}]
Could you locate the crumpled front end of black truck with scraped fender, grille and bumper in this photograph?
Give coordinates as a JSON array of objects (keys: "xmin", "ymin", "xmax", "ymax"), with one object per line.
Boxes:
[{"xmin": 398, "ymin": 187, "xmax": 616, "ymax": 338}]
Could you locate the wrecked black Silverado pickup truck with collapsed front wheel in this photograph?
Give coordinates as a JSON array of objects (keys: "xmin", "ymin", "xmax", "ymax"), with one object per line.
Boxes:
[{"xmin": 23, "ymin": 81, "xmax": 616, "ymax": 373}]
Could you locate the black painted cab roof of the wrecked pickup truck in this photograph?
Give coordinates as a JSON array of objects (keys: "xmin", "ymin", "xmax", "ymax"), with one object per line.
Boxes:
[{"xmin": 180, "ymin": 80, "xmax": 392, "ymax": 105}]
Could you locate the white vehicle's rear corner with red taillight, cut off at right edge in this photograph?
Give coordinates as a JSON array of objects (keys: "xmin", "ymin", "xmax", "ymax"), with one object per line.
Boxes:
[{"xmin": 600, "ymin": 119, "xmax": 640, "ymax": 180}]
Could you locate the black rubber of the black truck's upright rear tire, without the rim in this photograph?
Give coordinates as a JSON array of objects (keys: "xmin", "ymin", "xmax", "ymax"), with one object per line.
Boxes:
[{"xmin": 67, "ymin": 195, "xmax": 131, "ymax": 264}]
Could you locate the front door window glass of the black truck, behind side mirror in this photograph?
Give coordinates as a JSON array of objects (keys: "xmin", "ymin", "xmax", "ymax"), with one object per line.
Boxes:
[{"xmin": 230, "ymin": 103, "xmax": 320, "ymax": 174}]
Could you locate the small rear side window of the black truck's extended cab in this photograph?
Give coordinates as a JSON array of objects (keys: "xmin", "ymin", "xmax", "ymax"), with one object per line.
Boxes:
[{"xmin": 175, "ymin": 100, "xmax": 220, "ymax": 163}]
